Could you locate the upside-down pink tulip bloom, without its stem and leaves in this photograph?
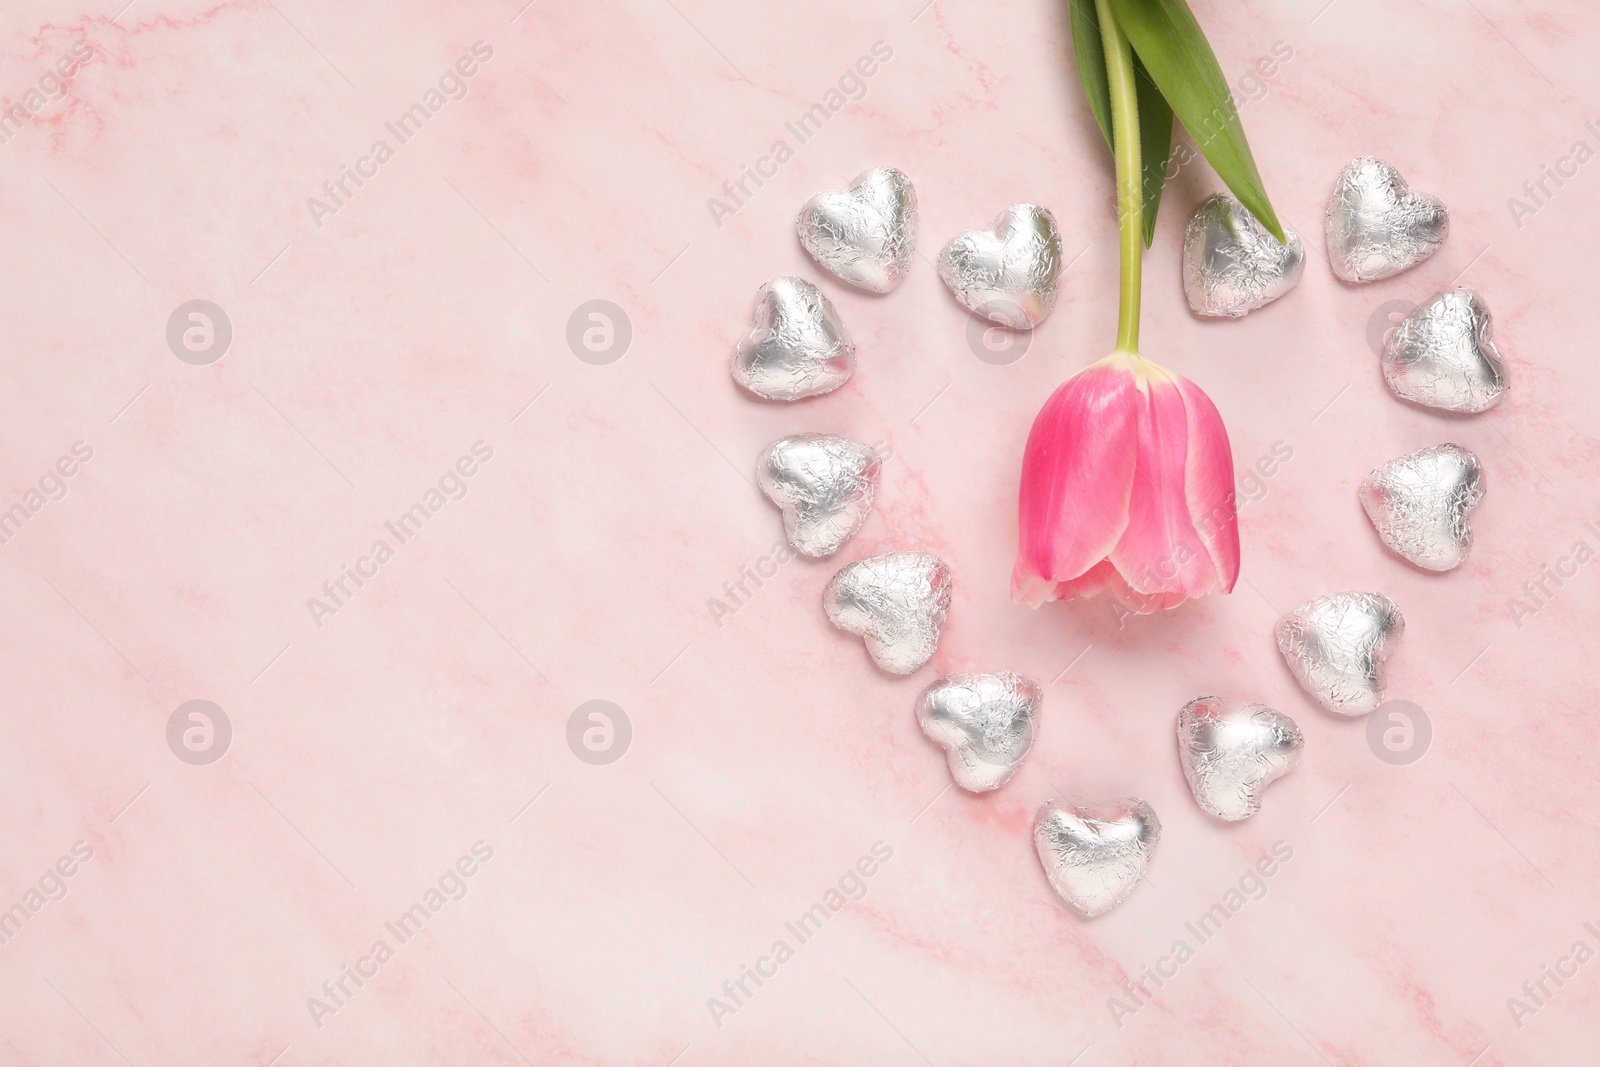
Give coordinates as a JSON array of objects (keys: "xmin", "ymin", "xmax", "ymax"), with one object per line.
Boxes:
[{"xmin": 1011, "ymin": 350, "xmax": 1238, "ymax": 613}]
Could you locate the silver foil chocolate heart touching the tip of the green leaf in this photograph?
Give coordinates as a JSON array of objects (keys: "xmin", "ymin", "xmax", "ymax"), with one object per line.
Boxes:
[{"xmin": 1184, "ymin": 192, "xmax": 1306, "ymax": 318}]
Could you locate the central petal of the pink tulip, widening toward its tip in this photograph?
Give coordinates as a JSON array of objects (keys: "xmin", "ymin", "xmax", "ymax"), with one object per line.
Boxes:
[{"xmin": 1109, "ymin": 365, "xmax": 1232, "ymax": 606}]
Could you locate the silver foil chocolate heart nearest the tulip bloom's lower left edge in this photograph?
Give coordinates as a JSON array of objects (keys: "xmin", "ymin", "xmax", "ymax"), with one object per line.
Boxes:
[{"xmin": 822, "ymin": 552, "xmax": 950, "ymax": 675}]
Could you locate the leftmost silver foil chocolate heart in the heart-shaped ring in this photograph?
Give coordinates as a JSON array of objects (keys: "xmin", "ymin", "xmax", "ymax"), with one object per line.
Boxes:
[{"xmin": 733, "ymin": 277, "xmax": 856, "ymax": 400}]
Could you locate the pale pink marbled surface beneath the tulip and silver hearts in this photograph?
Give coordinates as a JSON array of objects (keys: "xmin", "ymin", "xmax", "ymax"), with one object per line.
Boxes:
[{"xmin": 0, "ymin": 0, "xmax": 1600, "ymax": 1067}]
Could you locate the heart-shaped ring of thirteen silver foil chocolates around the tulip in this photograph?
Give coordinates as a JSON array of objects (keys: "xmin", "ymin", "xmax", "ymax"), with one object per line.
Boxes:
[{"xmin": 731, "ymin": 157, "xmax": 1506, "ymax": 917}]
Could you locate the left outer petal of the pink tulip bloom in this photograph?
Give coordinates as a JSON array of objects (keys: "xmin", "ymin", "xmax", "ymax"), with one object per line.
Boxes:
[{"xmin": 1011, "ymin": 355, "xmax": 1139, "ymax": 591}]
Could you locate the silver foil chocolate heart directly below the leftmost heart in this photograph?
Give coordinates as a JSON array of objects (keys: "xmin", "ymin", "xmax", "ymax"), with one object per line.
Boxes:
[{"xmin": 755, "ymin": 434, "xmax": 883, "ymax": 558}]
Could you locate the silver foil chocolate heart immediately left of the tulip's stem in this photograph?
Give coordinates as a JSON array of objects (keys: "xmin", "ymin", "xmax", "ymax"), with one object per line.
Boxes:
[{"xmin": 939, "ymin": 203, "xmax": 1061, "ymax": 330}]
